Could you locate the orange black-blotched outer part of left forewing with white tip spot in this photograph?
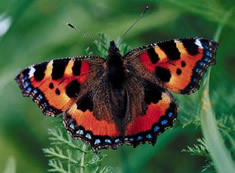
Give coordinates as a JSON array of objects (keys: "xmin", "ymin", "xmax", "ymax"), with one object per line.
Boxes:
[{"xmin": 16, "ymin": 57, "xmax": 103, "ymax": 116}]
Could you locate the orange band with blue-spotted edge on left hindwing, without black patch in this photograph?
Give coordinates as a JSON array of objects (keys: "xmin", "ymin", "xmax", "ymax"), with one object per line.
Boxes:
[{"xmin": 64, "ymin": 111, "xmax": 122, "ymax": 151}]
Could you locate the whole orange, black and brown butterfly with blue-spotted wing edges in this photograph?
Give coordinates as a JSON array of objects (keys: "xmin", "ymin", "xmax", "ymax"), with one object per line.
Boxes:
[{"xmin": 16, "ymin": 38, "xmax": 218, "ymax": 152}]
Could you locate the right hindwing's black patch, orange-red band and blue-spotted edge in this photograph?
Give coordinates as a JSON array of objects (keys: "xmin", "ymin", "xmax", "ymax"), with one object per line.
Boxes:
[{"xmin": 124, "ymin": 82, "xmax": 178, "ymax": 147}]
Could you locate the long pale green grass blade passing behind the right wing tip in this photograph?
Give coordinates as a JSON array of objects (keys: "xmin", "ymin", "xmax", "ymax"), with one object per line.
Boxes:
[{"xmin": 200, "ymin": 8, "xmax": 235, "ymax": 173}]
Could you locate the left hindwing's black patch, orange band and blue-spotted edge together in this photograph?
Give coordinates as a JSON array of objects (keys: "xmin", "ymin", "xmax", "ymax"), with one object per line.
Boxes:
[{"xmin": 64, "ymin": 93, "xmax": 122, "ymax": 151}]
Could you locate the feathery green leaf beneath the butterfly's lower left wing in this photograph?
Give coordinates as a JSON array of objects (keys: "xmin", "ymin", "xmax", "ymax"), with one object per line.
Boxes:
[{"xmin": 43, "ymin": 127, "xmax": 111, "ymax": 173}]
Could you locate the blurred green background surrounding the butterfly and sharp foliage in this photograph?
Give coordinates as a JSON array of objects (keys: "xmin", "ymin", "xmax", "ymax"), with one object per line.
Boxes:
[{"xmin": 0, "ymin": 0, "xmax": 235, "ymax": 173}]
